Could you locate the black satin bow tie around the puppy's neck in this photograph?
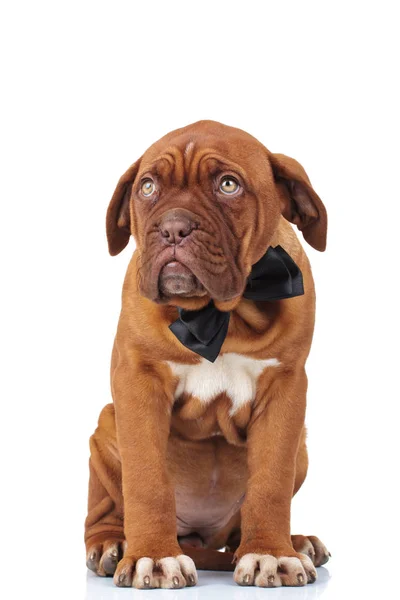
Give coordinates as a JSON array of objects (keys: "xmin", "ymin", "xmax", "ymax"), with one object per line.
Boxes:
[{"xmin": 169, "ymin": 246, "xmax": 304, "ymax": 362}]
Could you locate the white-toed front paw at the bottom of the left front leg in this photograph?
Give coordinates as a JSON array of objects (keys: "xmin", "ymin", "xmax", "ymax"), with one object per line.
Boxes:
[{"xmin": 114, "ymin": 554, "xmax": 197, "ymax": 589}]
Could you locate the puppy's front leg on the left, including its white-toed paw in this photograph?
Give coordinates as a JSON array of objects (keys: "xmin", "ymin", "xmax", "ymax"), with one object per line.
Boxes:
[{"xmin": 112, "ymin": 355, "xmax": 197, "ymax": 588}]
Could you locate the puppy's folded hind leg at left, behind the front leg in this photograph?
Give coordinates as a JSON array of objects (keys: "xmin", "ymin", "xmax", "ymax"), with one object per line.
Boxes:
[{"xmin": 85, "ymin": 404, "xmax": 125, "ymax": 577}]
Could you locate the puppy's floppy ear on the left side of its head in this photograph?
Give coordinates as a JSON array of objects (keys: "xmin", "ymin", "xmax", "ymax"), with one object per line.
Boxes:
[{"xmin": 106, "ymin": 158, "xmax": 141, "ymax": 256}]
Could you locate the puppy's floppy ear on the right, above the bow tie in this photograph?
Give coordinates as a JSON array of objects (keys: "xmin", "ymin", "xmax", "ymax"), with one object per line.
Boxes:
[{"xmin": 269, "ymin": 153, "xmax": 328, "ymax": 252}]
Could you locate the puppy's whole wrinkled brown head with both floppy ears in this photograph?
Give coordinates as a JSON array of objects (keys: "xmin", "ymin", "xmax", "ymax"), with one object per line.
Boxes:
[{"xmin": 107, "ymin": 121, "xmax": 327, "ymax": 309}]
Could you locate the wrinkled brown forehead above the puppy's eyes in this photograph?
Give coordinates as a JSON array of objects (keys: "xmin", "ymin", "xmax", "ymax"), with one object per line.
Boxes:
[{"xmin": 138, "ymin": 132, "xmax": 270, "ymax": 186}]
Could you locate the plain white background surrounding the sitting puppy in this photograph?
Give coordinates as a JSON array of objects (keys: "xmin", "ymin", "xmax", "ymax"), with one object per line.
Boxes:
[{"xmin": 0, "ymin": 0, "xmax": 400, "ymax": 600}]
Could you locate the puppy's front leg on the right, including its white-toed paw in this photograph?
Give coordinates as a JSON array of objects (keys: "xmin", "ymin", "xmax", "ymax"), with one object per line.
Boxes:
[{"xmin": 234, "ymin": 369, "xmax": 316, "ymax": 587}]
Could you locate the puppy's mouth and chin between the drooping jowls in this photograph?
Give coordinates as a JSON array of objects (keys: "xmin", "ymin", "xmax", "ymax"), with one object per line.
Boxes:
[{"xmin": 158, "ymin": 259, "xmax": 207, "ymax": 299}]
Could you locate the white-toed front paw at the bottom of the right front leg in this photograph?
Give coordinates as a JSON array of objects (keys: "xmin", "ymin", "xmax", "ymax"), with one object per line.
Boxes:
[{"xmin": 233, "ymin": 554, "xmax": 317, "ymax": 587}]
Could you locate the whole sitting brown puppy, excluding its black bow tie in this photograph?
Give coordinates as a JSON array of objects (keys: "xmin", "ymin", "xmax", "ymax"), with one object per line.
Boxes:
[{"xmin": 85, "ymin": 121, "xmax": 328, "ymax": 588}]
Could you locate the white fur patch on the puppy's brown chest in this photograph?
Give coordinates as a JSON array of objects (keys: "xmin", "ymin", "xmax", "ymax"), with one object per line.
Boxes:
[{"xmin": 167, "ymin": 352, "xmax": 280, "ymax": 415}]
